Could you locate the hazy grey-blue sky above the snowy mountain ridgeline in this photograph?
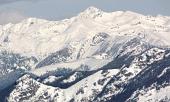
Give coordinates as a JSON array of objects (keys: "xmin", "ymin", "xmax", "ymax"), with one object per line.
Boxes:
[{"xmin": 0, "ymin": 0, "xmax": 170, "ymax": 24}]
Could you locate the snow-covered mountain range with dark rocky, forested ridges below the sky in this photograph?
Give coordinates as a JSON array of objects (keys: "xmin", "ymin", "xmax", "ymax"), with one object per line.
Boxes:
[{"xmin": 0, "ymin": 7, "xmax": 170, "ymax": 102}]
